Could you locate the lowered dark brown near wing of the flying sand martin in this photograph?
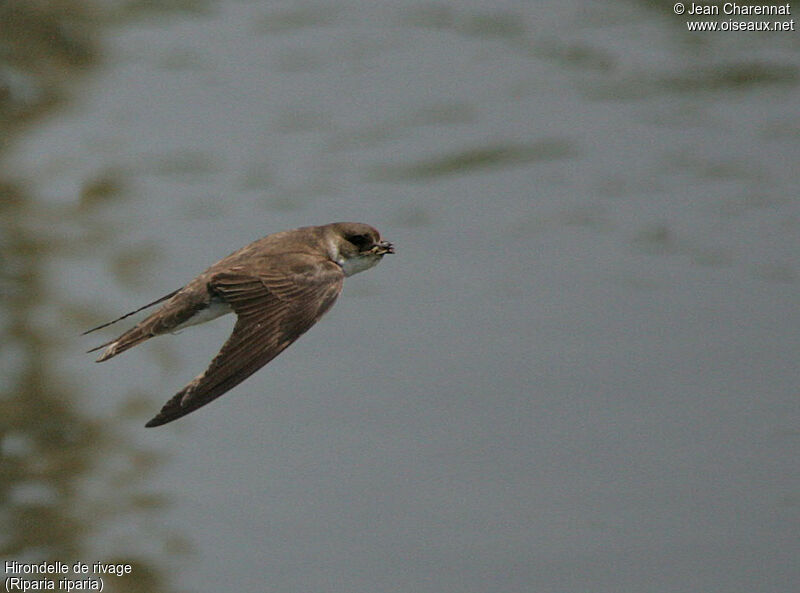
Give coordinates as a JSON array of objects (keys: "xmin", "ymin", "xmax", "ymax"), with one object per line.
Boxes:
[{"xmin": 146, "ymin": 256, "xmax": 344, "ymax": 426}]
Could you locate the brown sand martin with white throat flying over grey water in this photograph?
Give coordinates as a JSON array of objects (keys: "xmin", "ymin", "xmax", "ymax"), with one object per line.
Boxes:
[{"xmin": 84, "ymin": 222, "xmax": 394, "ymax": 426}]
